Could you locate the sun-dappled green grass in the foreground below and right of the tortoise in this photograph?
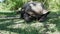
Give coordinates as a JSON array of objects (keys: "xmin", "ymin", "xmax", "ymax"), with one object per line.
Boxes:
[{"xmin": 0, "ymin": 11, "xmax": 60, "ymax": 34}]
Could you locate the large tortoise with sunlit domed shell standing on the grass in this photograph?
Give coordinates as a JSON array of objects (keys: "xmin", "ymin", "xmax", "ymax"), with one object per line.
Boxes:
[{"xmin": 17, "ymin": 2, "xmax": 50, "ymax": 22}]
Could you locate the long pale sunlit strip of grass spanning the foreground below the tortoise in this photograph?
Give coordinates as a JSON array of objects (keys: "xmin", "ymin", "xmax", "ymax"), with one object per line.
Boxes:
[{"xmin": 7, "ymin": 23, "xmax": 44, "ymax": 29}]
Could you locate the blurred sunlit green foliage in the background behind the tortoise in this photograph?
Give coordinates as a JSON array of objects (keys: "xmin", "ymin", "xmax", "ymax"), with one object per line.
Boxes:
[{"xmin": 0, "ymin": 0, "xmax": 60, "ymax": 11}]
